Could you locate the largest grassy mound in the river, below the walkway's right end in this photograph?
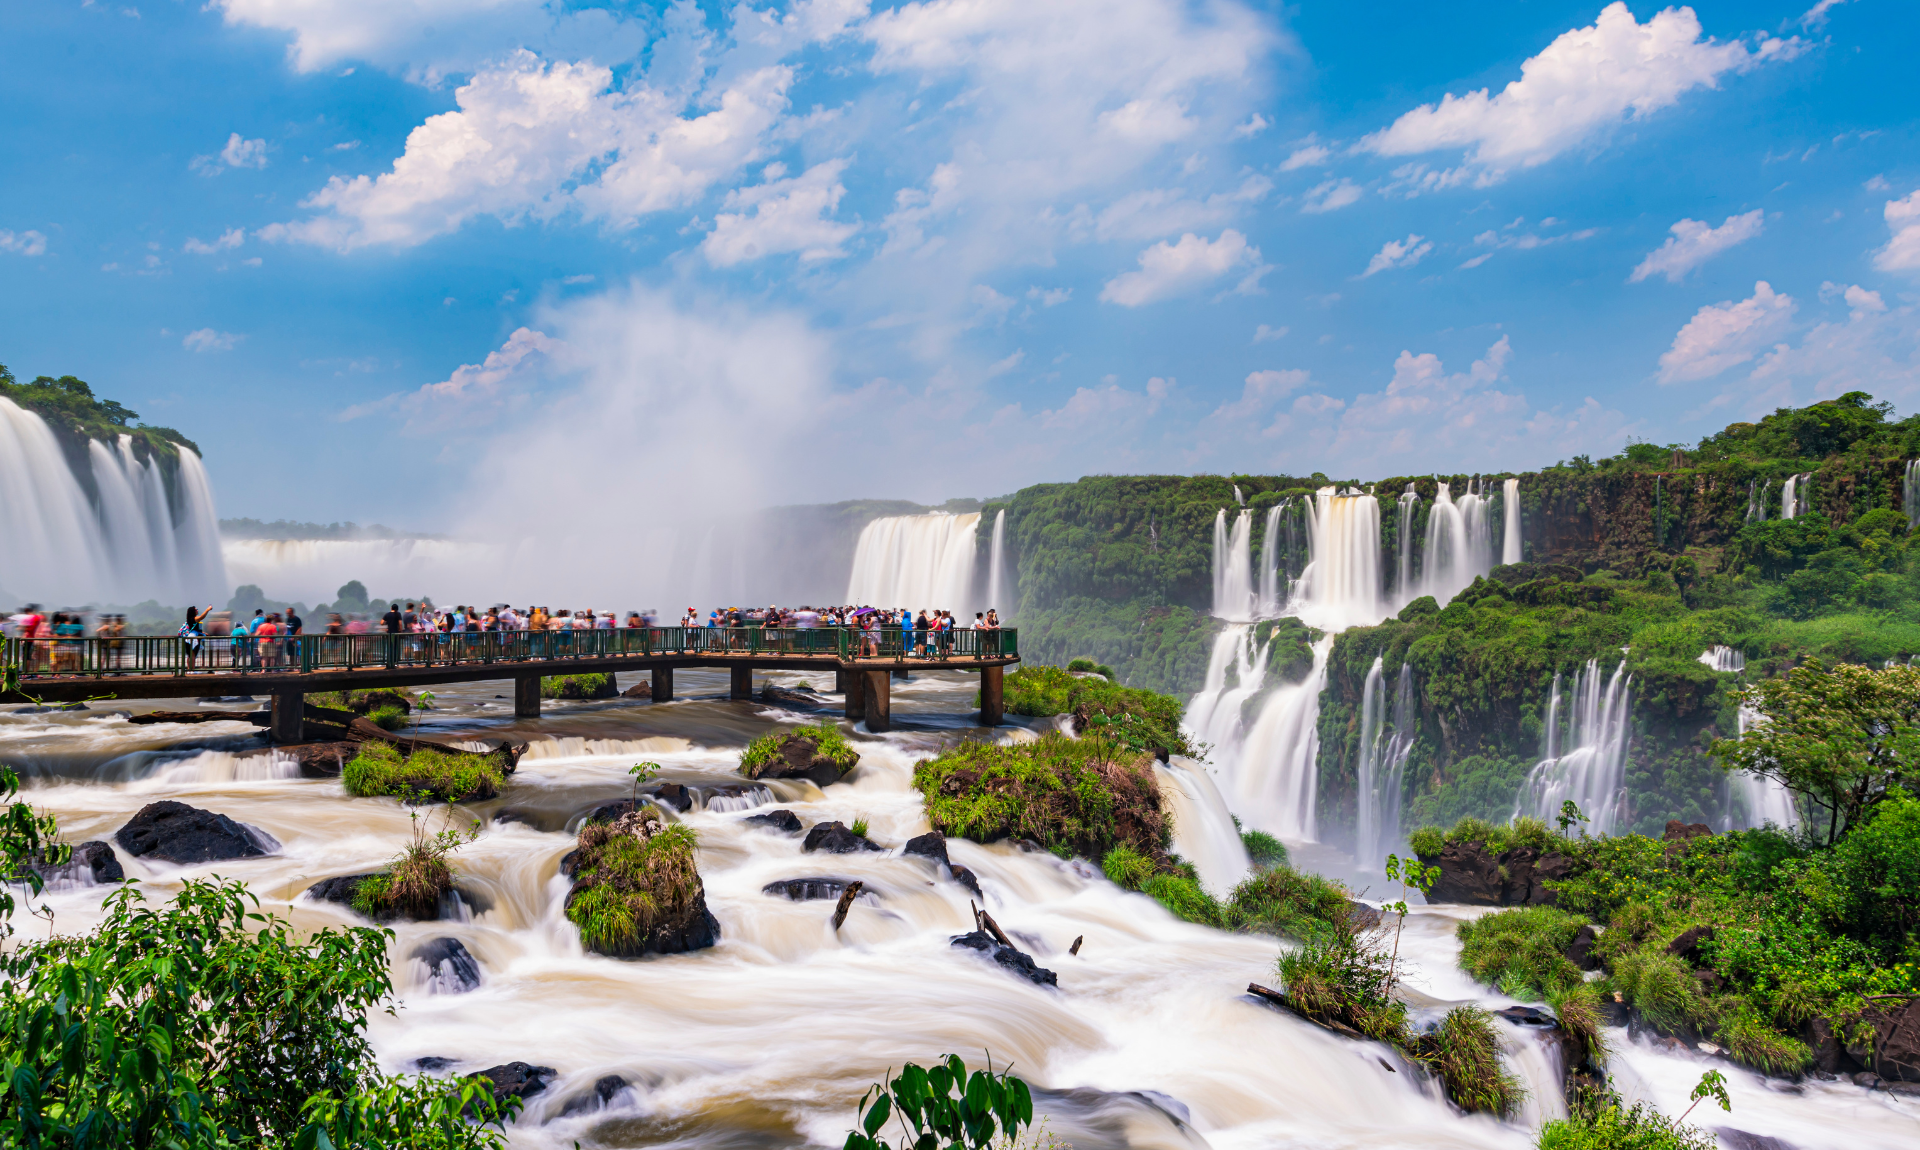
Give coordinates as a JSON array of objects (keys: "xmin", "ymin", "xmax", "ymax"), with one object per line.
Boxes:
[{"xmin": 914, "ymin": 731, "xmax": 1171, "ymax": 858}]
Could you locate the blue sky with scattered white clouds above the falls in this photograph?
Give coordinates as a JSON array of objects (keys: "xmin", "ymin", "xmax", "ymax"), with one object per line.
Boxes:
[{"xmin": 0, "ymin": 0, "xmax": 1920, "ymax": 532}]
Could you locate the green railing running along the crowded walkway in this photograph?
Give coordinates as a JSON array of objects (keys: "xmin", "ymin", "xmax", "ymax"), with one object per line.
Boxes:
[{"xmin": 6, "ymin": 628, "xmax": 1020, "ymax": 680}]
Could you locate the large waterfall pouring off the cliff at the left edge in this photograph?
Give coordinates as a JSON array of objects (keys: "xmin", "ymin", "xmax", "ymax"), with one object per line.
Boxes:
[{"xmin": 0, "ymin": 399, "xmax": 230, "ymax": 607}]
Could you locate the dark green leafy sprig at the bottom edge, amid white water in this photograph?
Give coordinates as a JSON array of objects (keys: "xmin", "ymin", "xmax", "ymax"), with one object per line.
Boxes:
[{"xmin": 845, "ymin": 1054, "xmax": 1033, "ymax": 1150}]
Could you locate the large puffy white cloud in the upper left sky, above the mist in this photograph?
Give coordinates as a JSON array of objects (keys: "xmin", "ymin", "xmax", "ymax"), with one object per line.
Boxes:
[{"xmin": 261, "ymin": 52, "xmax": 793, "ymax": 252}]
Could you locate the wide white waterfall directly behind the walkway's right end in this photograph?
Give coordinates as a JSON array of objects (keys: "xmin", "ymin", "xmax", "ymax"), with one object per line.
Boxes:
[{"xmin": 847, "ymin": 511, "xmax": 979, "ymax": 618}]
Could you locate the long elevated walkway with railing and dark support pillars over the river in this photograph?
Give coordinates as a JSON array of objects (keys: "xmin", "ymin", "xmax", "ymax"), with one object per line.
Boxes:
[{"xmin": 0, "ymin": 628, "xmax": 1020, "ymax": 743}]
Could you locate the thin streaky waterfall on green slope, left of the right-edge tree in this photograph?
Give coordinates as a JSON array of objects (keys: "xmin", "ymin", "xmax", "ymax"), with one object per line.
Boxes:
[{"xmin": 1513, "ymin": 659, "xmax": 1634, "ymax": 835}]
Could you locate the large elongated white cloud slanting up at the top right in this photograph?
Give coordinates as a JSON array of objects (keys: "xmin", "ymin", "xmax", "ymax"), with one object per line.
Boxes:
[{"xmin": 1359, "ymin": 0, "xmax": 1805, "ymax": 186}]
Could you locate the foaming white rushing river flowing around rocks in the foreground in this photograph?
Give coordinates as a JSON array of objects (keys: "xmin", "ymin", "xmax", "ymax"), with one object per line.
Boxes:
[{"xmin": 0, "ymin": 672, "xmax": 1920, "ymax": 1150}]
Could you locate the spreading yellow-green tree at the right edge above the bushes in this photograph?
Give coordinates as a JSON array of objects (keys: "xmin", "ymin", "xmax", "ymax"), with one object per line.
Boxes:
[{"xmin": 1713, "ymin": 659, "xmax": 1920, "ymax": 843}]
